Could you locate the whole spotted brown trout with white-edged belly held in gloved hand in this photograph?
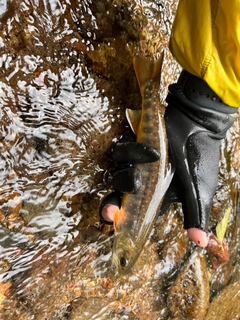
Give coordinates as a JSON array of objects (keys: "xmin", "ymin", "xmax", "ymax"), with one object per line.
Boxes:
[{"xmin": 112, "ymin": 52, "xmax": 174, "ymax": 274}]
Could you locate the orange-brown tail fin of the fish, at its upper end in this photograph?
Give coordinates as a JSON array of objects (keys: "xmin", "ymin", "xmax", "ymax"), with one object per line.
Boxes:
[{"xmin": 133, "ymin": 51, "xmax": 164, "ymax": 93}]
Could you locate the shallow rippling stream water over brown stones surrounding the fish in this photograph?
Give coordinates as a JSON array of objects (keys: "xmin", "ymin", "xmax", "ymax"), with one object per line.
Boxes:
[{"xmin": 0, "ymin": 0, "xmax": 240, "ymax": 320}]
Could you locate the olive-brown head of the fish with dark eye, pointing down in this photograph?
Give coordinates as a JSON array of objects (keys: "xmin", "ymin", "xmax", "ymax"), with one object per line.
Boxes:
[{"xmin": 112, "ymin": 231, "xmax": 139, "ymax": 274}]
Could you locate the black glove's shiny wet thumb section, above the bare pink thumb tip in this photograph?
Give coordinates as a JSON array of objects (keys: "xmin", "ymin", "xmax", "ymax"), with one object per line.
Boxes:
[{"xmin": 183, "ymin": 132, "xmax": 220, "ymax": 231}]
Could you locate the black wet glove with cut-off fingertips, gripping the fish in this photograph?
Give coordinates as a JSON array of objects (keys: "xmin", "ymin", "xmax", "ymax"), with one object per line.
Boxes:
[{"xmin": 100, "ymin": 71, "xmax": 237, "ymax": 231}]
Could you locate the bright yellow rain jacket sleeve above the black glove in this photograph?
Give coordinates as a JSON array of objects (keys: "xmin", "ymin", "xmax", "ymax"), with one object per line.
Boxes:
[{"xmin": 170, "ymin": 0, "xmax": 240, "ymax": 107}]
